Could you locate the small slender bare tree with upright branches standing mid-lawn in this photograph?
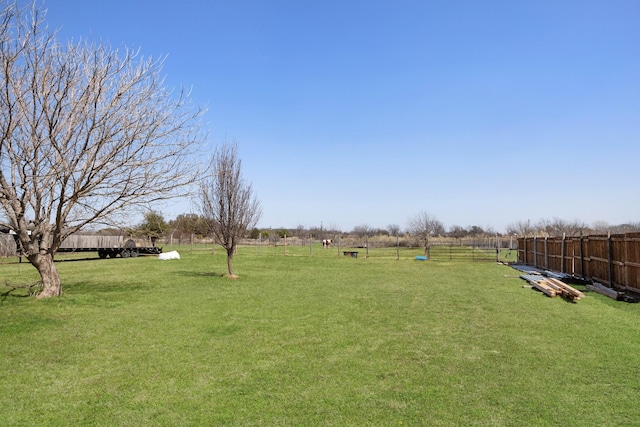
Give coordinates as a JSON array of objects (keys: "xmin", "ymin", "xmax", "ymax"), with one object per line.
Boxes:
[{"xmin": 200, "ymin": 143, "xmax": 262, "ymax": 277}]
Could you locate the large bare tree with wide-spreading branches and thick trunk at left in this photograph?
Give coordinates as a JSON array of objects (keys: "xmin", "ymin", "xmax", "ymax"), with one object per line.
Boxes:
[{"xmin": 0, "ymin": 3, "xmax": 202, "ymax": 297}]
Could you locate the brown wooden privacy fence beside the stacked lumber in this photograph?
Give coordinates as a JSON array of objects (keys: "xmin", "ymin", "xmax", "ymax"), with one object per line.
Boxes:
[{"xmin": 518, "ymin": 233, "xmax": 640, "ymax": 294}]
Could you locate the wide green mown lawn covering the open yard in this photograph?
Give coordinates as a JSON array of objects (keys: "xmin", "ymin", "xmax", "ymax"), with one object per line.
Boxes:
[{"xmin": 0, "ymin": 247, "xmax": 640, "ymax": 426}]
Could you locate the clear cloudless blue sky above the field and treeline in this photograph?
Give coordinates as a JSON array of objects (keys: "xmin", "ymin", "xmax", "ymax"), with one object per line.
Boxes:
[{"xmin": 45, "ymin": 0, "xmax": 640, "ymax": 231}]
